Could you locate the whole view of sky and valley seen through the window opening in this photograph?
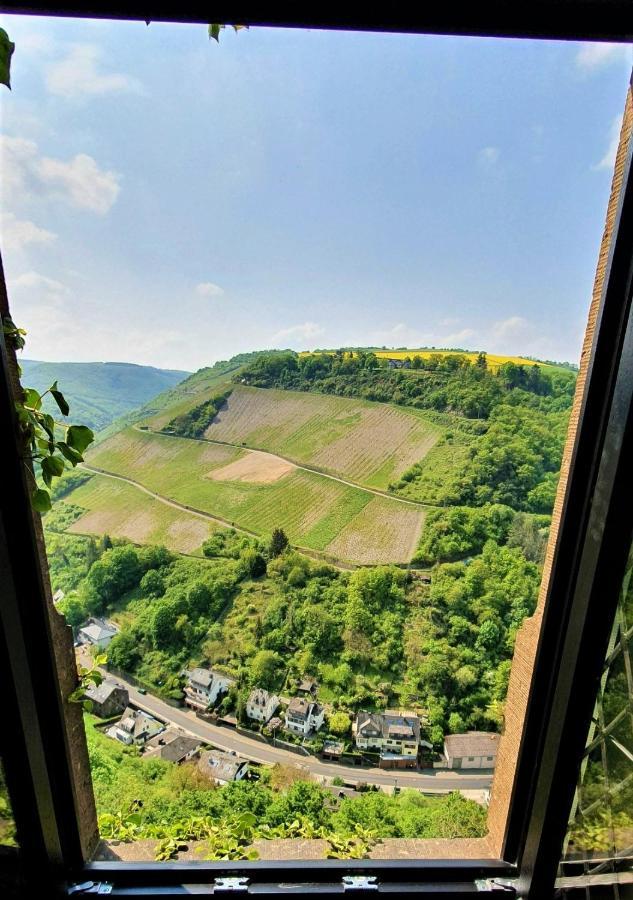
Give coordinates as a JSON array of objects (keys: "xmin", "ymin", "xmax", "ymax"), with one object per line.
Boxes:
[{"xmin": 3, "ymin": 10, "xmax": 629, "ymax": 859}]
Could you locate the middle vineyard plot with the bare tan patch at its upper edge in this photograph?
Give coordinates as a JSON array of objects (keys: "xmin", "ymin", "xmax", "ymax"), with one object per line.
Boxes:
[{"xmin": 82, "ymin": 428, "xmax": 424, "ymax": 563}]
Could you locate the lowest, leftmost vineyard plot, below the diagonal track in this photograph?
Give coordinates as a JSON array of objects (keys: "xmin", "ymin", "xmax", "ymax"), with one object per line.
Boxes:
[{"xmin": 61, "ymin": 475, "xmax": 222, "ymax": 555}]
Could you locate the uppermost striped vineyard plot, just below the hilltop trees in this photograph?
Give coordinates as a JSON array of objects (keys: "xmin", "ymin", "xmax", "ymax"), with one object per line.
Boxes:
[{"xmin": 205, "ymin": 385, "xmax": 442, "ymax": 490}]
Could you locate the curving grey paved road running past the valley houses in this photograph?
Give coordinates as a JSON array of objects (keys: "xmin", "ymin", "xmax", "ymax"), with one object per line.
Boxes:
[{"xmin": 100, "ymin": 678, "xmax": 492, "ymax": 793}]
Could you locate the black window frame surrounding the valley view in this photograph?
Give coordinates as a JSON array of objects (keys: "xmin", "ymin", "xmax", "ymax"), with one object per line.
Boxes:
[{"xmin": 0, "ymin": 0, "xmax": 633, "ymax": 898}]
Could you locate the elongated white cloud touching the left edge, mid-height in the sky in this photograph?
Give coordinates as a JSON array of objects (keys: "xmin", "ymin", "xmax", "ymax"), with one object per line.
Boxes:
[{"xmin": 0, "ymin": 135, "xmax": 120, "ymax": 215}]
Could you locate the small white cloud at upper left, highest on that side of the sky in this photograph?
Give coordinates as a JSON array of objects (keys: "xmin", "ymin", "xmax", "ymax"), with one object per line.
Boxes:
[{"xmin": 44, "ymin": 44, "xmax": 142, "ymax": 99}]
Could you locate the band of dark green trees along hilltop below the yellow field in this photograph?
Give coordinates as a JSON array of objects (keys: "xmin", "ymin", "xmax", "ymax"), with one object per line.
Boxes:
[{"xmin": 239, "ymin": 351, "xmax": 576, "ymax": 419}]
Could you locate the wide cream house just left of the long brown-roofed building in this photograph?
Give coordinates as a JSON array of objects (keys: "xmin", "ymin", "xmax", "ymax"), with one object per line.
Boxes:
[{"xmin": 352, "ymin": 710, "xmax": 420, "ymax": 768}]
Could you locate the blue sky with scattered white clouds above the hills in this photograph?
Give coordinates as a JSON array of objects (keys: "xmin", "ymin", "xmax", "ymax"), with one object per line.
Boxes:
[{"xmin": 0, "ymin": 16, "xmax": 632, "ymax": 370}]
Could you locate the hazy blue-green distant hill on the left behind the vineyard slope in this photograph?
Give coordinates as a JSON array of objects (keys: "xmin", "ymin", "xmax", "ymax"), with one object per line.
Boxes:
[{"xmin": 20, "ymin": 359, "xmax": 189, "ymax": 431}]
